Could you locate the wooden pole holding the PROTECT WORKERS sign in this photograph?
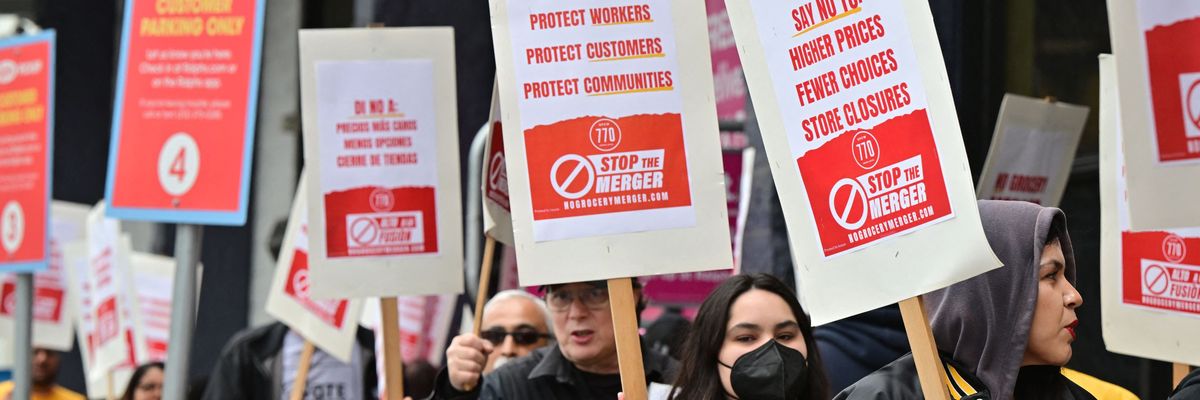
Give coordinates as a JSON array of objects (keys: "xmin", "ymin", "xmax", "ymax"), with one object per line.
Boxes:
[{"xmin": 608, "ymin": 277, "xmax": 647, "ymax": 400}]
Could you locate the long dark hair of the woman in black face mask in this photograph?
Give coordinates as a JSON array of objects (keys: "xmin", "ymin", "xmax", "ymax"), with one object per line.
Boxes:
[{"xmin": 670, "ymin": 274, "xmax": 829, "ymax": 400}]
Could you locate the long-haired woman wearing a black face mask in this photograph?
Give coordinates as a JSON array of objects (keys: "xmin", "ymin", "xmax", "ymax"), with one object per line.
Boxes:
[{"xmin": 670, "ymin": 274, "xmax": 829, "ymax": 400}]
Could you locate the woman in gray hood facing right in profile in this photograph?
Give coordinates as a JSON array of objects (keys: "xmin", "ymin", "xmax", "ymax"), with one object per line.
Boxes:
[{"xmin": 835, "ymin": 201, "xmax": 1094, "ymax": 400}]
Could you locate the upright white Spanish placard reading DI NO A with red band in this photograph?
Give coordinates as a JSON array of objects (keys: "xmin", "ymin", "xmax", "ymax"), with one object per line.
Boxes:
[{"xmin": 300, "ymin": 28, "xmax": 462, "ymax": 295}]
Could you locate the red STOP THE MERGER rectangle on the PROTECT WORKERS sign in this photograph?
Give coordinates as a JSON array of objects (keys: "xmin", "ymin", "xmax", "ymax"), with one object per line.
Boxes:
[{"xmin": 524, "ymin": 114, "xmax": 691, "ymax": 221}]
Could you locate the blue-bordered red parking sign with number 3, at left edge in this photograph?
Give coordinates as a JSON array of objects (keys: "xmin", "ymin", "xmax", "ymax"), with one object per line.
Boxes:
[{"xmin": 0, "ymin": 31, "xmax": 54, "ymax": 272}]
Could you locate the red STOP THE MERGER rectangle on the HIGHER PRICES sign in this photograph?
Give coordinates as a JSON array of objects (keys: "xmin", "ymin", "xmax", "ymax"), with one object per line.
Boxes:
[{"xmin": 796, "ymin": 109, "xmax": 953, "ymax": 257}]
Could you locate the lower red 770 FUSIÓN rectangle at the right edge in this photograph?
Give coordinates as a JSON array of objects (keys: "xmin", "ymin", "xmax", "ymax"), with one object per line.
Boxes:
[{"xmin": 1121, "ymin": 232, "xmax": 1200, "ymax": 316}]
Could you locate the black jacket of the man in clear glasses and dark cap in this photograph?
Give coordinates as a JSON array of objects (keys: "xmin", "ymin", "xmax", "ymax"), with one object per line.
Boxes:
[{"xmin": 427, "ymin": 338, "xmax": 679, "ymax": 400}]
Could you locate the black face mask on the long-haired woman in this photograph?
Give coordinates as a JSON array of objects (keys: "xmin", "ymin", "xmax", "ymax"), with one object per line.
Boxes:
[{"xmin": 716, "ymin": 340, "xmax": 809, "ymax": 400}]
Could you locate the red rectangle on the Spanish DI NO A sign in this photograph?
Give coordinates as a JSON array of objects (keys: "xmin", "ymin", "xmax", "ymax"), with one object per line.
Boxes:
[{"xmin": 325, "ymin": 187, "xmax": 438, "ymax": 258}]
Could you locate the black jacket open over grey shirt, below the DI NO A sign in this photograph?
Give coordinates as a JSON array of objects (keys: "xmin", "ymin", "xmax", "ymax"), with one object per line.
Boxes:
[{"xmin": 203, "ymin": 322, "xmax": 378, "ymax": 400}]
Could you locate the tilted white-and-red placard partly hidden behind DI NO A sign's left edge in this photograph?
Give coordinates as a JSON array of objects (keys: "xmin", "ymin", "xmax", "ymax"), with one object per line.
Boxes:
[{"xmin": 266, "ymin": 172, "xmax": 362, "ymax": 363}]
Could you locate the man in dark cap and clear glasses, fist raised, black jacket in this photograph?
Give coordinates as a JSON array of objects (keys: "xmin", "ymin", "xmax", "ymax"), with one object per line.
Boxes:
[{"xmin": 431, "ymin": 280, "xmax": 678, "ymax": 400}]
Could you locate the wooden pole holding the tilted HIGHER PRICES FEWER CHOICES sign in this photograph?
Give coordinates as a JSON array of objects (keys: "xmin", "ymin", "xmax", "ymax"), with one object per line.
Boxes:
[{"xmin": 900, "ymin": 295, "xmax": 950, "ymax": 400}]
